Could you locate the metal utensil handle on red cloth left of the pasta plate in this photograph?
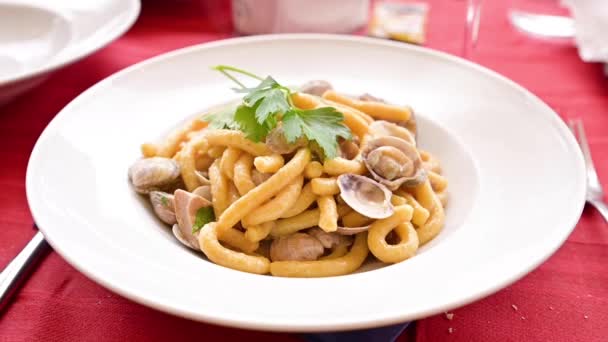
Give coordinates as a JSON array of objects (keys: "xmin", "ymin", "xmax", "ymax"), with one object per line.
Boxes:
[{"xmin": 0, "ymin": 227, "xmax": 48, "ymax": 311}]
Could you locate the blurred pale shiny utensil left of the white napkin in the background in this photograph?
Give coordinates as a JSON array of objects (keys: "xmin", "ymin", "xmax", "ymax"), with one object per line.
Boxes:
[{"xmin": 509, "ymin": 10, "xmax": 575, "ymax": 40}]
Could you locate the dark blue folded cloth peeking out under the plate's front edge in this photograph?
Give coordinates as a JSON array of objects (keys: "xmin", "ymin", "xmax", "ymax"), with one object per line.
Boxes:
[{"xmin": 304, "ymin": 323, "xmax": 409, "ymax": 342}]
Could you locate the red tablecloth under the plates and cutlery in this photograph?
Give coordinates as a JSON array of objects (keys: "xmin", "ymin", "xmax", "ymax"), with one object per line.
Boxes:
[{"xmin": 0, "ymin": 0, "xmax": 608, "ymax": 341}]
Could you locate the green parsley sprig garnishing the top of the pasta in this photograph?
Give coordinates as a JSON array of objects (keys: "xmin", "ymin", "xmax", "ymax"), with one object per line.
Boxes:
[{"xmin": 203, "ymin": 65, "xmax": 351, "ymax": 159}]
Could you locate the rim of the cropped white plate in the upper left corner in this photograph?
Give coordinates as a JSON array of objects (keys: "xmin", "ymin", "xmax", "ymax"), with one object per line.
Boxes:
[{"xmin": 0, "ymin": 0, "xmax": 141, "ymax": 87}]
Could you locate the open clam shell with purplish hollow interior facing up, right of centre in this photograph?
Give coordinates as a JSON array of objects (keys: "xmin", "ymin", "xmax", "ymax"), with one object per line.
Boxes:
[{"xmin": 338, "ymin": 173, "xmax": 394, "ymax": 219}]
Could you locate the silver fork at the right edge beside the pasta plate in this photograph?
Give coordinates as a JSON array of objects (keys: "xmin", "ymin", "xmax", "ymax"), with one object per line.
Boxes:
[{"xmin": 568, "ymin": 119, "xmax": 608, "ymax": 222}]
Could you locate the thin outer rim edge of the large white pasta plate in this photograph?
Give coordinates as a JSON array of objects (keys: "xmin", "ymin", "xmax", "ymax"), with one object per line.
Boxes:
[{"xmin": 26, "ymin": 33, "xmax": 586, "ymax": 332}]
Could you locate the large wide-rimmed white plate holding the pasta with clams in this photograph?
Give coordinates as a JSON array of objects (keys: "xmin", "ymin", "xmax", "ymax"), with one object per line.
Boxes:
[{"xmin": 27, "ymin": 35, "xmax": 585, "ymax": 331}]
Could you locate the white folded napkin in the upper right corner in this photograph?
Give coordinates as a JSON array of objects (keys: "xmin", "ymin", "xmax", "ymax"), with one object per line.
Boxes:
[{"xmin": 562, "ymin": 0, "xmax": 608, "ymax": 63}]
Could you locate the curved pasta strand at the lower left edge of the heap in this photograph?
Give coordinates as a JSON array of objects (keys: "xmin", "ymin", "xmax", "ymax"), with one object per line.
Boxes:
[{"xmin": 198, "ymin": 222, "xmax": 270, "ymax": 274}]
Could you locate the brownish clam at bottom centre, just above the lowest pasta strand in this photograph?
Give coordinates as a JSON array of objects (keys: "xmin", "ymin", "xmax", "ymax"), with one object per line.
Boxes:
[{"xmin": 270, "ymin": 233, "xmax": 325, "ymax": 261}]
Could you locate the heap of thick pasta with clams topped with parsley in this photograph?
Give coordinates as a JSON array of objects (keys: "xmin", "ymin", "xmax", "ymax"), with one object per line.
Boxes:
[{"xmin": 129, "ymin": 65, "xmax": 447, "ymax": 277}]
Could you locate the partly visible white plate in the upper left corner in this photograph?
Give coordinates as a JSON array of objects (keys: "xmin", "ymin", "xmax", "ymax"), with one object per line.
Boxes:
[{"xmin": 0, "ymin": 0, "xmax": 140, "ymax": 104}]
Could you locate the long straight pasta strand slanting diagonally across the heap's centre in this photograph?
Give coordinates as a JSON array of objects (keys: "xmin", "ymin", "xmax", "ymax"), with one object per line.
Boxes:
[{"xmin": 216, "ymin": 148, "xmax": 310, "ymax": 236}]
